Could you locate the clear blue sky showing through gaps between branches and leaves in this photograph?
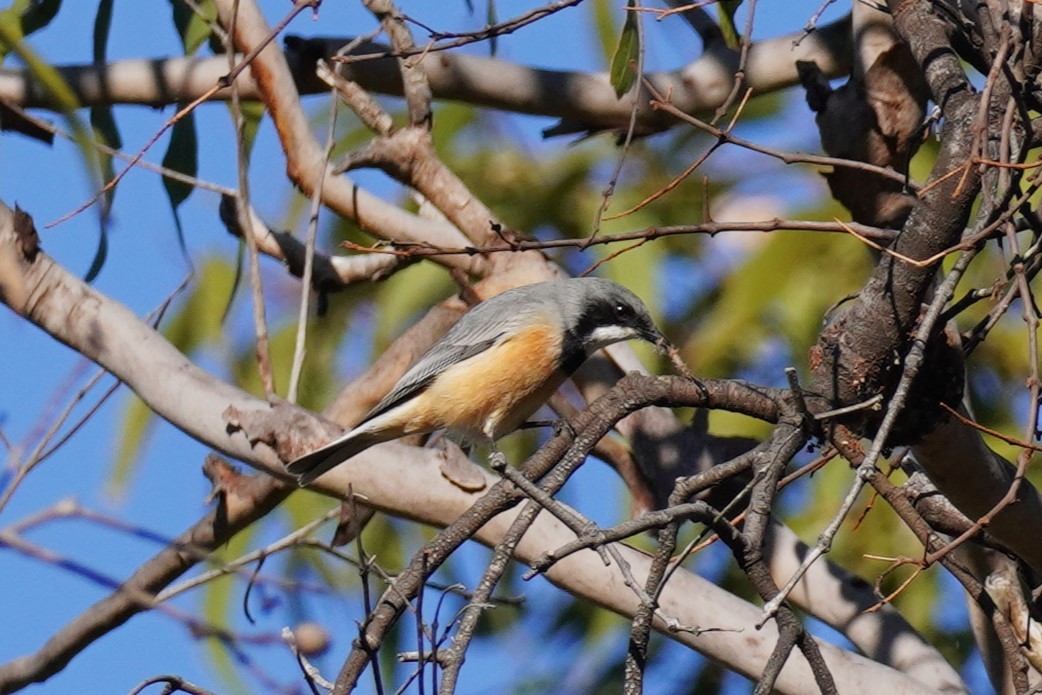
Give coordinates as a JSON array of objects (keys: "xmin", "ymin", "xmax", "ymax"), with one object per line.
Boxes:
[{"xmin": 0, "ymin": 0, "xmax": 983, "ymax": 693}]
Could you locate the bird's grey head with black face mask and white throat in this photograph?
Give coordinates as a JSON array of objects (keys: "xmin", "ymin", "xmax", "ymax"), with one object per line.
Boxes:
[{"xmin": 554, "ymin": 277, "xmax": 667, "ymax": 364}]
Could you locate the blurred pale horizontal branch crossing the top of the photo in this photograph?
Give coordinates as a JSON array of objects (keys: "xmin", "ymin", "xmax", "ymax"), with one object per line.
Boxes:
[{"xmin": 0, "ymin": 19, "xmax": 850, "ymax": 132}]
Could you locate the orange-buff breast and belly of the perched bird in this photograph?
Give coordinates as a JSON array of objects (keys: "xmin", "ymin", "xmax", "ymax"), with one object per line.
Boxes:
[{"xmin": 408, "ymin": 327, "xmax": 565, "ymax": 439}]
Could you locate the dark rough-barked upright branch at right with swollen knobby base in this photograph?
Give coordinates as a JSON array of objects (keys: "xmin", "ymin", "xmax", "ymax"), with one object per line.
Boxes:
[{"xmin": 812, "ymin": 2, "xmax": 985, "ymax": 429}]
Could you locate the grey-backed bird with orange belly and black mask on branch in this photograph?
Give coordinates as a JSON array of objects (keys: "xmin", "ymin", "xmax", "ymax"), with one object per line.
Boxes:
[{"xmin": 287, "ymin": 277, "xmax": 669, "ymax": 486}]
